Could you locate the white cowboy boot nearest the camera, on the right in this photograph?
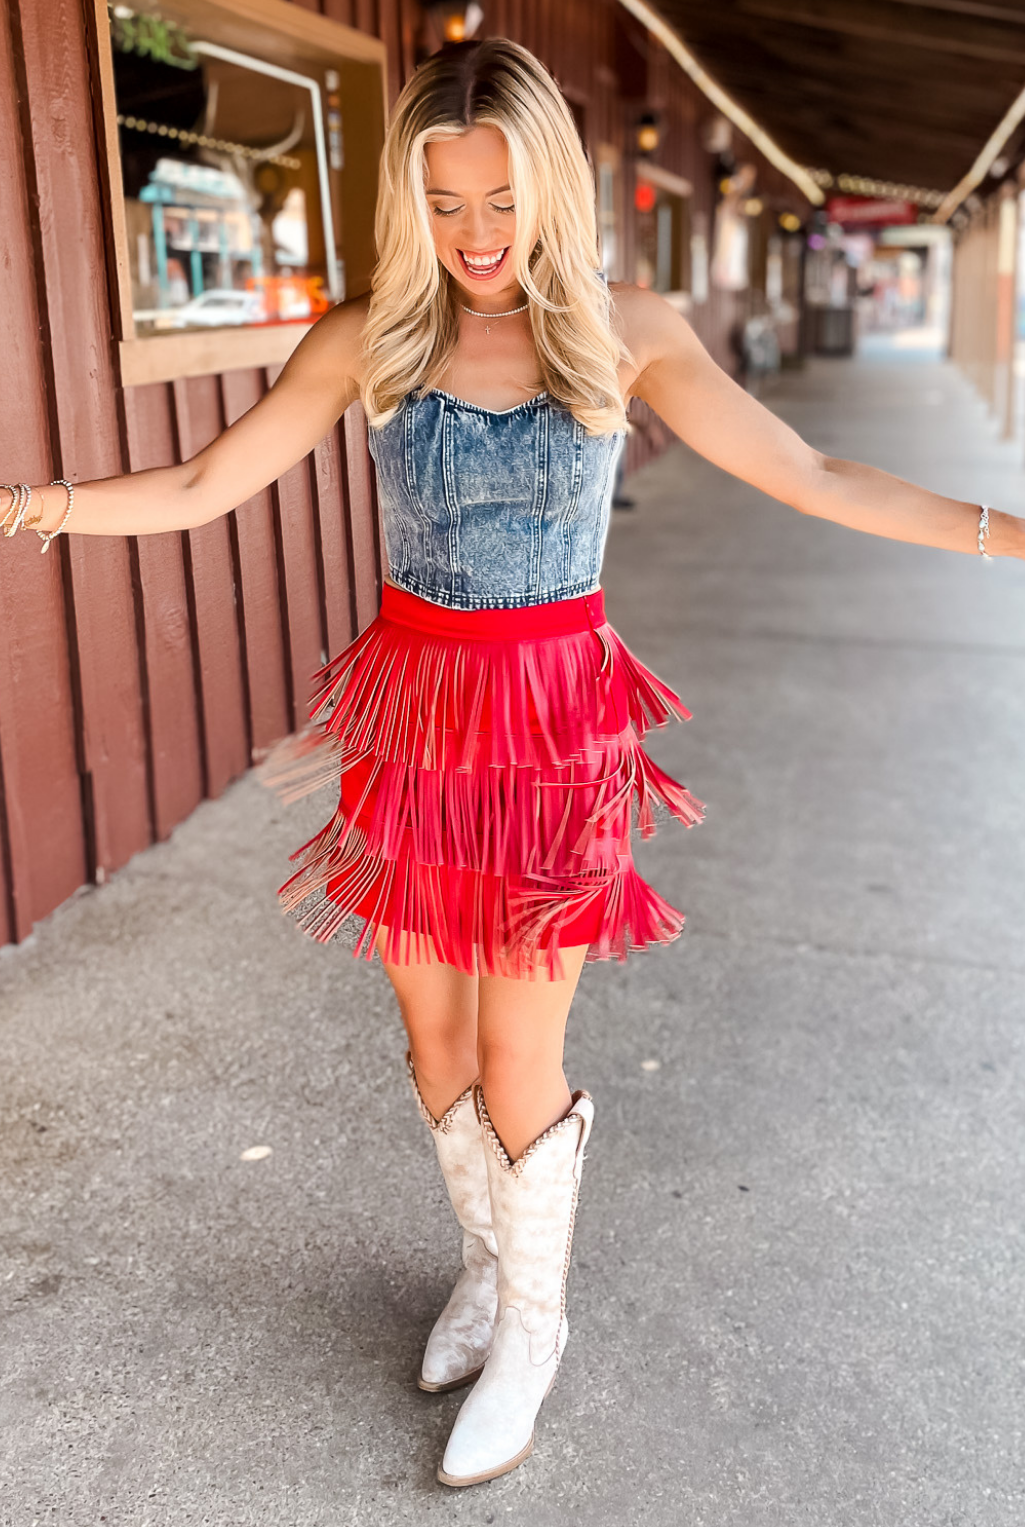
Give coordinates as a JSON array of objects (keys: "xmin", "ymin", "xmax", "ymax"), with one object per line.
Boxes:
[{"xmin": 438, "ymin": 1086, "xmax": 594, "ymax": 1484}]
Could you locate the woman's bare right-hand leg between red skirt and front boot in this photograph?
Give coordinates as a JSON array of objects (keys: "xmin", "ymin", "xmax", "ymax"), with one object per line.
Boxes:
[{"xmin": 477, "ymin": 944, "xmax": 587, "ymax": 1161}]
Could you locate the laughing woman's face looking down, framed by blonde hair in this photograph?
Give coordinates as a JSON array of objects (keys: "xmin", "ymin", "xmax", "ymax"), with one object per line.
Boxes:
[{"xmin": 425, "ymin": 127, "xmax": 521, "ymax": 312}]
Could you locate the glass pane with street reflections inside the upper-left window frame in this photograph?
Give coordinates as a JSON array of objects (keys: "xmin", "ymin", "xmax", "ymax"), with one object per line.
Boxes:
[{"xmin": 108, "ymin": 3, "xmax": 344, "ymax": 334}]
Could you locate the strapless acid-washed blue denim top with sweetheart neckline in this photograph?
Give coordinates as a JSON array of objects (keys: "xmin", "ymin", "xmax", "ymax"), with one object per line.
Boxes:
[{"xmin": 368, "ymin": 277, "xmax": 626, "ymax": 609}]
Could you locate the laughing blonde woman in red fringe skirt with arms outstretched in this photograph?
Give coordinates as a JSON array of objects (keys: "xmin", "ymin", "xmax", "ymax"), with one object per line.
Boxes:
[{"xmin": 0, "ymin": 38, "xmax": 1025, "ymax": 1486}]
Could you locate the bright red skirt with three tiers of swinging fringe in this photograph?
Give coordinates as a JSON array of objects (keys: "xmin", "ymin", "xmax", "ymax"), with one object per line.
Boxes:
[{"xmin": 258, "ymin": 583, "xmax": 704, "ymax": 979}]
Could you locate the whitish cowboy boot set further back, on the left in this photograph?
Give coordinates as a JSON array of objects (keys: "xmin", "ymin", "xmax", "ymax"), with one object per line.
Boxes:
[{"xmin": 406, "ymin": 1054, "xmax": 498, "ymax": 1393}]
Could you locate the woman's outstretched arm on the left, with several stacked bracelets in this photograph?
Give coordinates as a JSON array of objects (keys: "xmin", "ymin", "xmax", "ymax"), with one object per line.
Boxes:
[{"xmin": 0, "ymin": 295, "xmax": 368, "ymax": 536}]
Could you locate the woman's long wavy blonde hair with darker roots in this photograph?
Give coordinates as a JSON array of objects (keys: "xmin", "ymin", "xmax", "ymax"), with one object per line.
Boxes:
[{"xmin": 361, "ymin": 37, "xmax": 632, "ymax": 435}]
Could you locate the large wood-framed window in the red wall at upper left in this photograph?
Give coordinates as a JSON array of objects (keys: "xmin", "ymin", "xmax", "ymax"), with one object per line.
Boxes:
[{"xmin": 96, "ymin": 0, "xmax": 385, "ymax": 385}]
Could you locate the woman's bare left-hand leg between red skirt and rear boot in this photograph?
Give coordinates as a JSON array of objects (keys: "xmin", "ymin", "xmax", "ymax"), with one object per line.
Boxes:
[{"xmin": 377, "ymin": 928, "xmax": 478, "ymax": 1119}]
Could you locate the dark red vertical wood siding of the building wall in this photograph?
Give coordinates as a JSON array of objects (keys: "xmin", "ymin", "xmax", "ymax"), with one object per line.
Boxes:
[{"xmin": 0, "ymin": 0, "xmax": 800, "ymax": 944}]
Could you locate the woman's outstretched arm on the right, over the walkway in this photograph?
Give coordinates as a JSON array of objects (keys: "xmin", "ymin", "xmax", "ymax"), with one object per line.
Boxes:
[{"xmin": 617, "ymin": 287, "xmax": 1025, "ymax": 559}]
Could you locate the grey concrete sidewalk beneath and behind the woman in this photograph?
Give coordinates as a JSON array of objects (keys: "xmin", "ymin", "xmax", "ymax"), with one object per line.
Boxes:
[{"xmin": 0, "ymin": 354, "xmax": 1025, "ymax": 1527}]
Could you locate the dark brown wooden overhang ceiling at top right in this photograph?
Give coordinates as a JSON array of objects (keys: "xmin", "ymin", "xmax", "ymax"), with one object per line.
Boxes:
[{"xmin": 654, "ymin": 0, "xmax": 1025, "ymax": 200}]
